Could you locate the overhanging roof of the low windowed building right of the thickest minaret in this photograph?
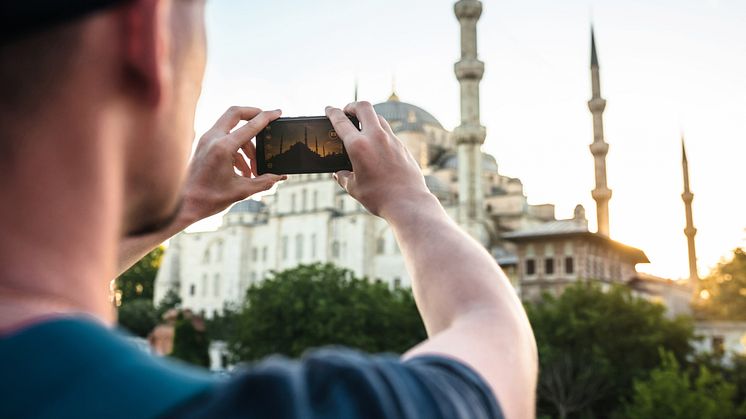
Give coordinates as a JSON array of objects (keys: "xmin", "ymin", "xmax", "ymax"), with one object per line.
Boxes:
[{"xmin": 502, "ymin": 219, "xmax": 650, "ymax": 263}]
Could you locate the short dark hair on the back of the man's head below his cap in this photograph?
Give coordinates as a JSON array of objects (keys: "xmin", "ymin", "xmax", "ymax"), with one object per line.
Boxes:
[{"xmin": 0, "ymin": 22, "xmax": 82, "ymax": 162}]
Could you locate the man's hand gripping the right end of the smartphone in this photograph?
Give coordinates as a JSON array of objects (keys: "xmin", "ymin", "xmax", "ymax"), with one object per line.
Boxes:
[{"xmin": 326, "ymin": 102, "xmax": 431, "ymax": 219}]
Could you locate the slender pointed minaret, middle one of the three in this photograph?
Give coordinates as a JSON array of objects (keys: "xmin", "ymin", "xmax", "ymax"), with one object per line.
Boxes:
[{"xmin": 588, "ymin": 27, "xmax": 611, "ymax": 237}]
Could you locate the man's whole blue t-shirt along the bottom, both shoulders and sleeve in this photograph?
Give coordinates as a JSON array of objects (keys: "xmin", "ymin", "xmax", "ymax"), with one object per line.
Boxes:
[{"xmin": 0, "ymin": 318, "xmax": 502, "ymax": 419}]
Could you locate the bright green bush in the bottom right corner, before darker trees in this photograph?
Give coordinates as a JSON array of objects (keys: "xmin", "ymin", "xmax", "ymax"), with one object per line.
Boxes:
[{"xmin": 615, "ymin": 352, "xmax": 744, "ymax": 419}]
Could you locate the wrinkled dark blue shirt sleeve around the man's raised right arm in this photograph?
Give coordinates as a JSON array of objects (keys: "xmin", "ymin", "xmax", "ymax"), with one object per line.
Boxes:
[{"xmin": 166, "ymin": 348, "xmax": 502, "ymax": 418}]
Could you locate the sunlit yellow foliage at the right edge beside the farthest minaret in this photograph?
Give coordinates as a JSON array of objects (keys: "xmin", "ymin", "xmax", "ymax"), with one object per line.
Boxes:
[{"xmin": 697, "ymin": 249, "xmax": 746, "ymax": 320}]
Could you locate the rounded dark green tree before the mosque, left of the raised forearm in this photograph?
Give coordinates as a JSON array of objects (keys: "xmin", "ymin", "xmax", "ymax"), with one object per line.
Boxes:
[{"xmin": 229, "ymin": 264, "xmax": 426, "ymax": 361}]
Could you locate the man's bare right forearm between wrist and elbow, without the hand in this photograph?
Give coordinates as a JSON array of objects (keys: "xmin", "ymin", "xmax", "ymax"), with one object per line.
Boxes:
[{"xmin": 386, "ymin": 194, "xmax": 524, "ymax": 335}]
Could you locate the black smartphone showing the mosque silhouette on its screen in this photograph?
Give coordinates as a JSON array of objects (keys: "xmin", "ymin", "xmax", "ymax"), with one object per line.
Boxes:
[{"xmin": 256, "ymin": 116, "xmax": 360, "ymax": 175}]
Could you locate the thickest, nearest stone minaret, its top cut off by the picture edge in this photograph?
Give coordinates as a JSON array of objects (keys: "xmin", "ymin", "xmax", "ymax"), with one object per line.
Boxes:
[{"xmin": 453, "ymin": 0, "xmax": 488, "ymax": 244}]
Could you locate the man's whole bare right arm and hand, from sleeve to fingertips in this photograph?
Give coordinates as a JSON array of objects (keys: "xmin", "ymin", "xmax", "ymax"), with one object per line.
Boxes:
[{"xmin": 327, "ymin": 102, "xmax": 538, "ymax": 419}]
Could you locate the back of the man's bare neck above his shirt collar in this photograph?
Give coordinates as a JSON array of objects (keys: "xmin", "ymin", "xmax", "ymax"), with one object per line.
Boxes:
[{"xmin": 0, "ymin": 105, "xmax": 123, "ymax": 330}]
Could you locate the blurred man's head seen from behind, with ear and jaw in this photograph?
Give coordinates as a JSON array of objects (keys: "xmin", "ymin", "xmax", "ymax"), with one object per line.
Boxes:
[{"xmin": 0, "ymin": 0, "xmax": 206, "ymax": 233}]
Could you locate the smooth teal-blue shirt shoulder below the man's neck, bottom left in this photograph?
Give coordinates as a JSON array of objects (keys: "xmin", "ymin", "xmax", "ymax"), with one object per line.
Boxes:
[{"xmin": 0, "ymin": 317, "xmax": 216, "ymax": 418}]
